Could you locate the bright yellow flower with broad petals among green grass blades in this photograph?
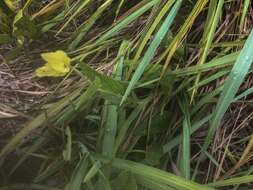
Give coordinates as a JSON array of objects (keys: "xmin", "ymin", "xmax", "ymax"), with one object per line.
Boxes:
[{"xmin": 36, "ymin": 50, "xmax": 71, "ymax": 77}]
